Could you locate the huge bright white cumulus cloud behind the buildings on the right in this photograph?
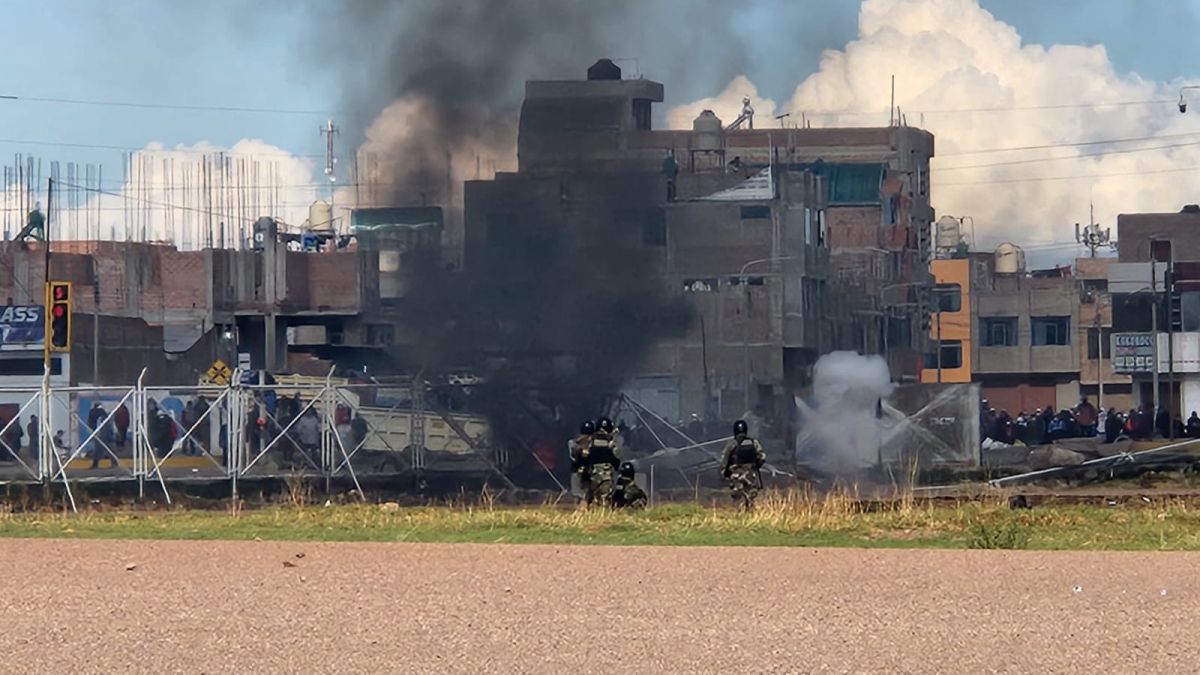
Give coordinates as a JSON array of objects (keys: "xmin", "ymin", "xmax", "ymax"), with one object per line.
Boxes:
[{"xmin": 667, "ymin": 0, "xmax": 1200, "ymax": 257}]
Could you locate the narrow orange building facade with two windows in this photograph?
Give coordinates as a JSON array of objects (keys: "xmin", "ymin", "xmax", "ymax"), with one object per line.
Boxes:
[{"xmin": 920, "ymin": 258, "xmax": 971, "ymax": 382}]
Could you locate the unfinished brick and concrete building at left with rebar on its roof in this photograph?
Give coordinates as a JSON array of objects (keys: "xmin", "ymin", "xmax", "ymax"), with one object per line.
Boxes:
[{"xmin": 0, "ymin": 232, "xmax": 390, "ymax": 386}]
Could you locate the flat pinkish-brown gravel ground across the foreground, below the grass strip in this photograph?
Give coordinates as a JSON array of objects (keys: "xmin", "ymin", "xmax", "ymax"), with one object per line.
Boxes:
[{"xmin": 0, "ymin": 539, "xmax": 1200, "ymax": 674}]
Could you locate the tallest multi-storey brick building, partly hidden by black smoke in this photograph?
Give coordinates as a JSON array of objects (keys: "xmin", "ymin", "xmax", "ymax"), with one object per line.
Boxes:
[{"xmin": 464, "ymin": 61, "xmax": 934, "ymax": 432}]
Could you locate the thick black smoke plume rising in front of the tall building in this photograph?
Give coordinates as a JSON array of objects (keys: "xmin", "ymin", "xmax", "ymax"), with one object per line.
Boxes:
[{"xmin": 292, "ymin": 0, "xmax": 745, "ymax": 451}]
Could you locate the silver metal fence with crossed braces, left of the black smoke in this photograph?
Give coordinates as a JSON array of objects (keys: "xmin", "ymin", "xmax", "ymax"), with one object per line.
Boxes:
[{"xmin": 0, "ymin": 371, "xmax": 515, "ymax": 508}]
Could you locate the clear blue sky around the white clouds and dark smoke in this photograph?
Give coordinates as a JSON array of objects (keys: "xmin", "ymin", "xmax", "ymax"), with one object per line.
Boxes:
[{"xmin": 0, "ymin": 0, "xmax": 1200, "ymax": 182}]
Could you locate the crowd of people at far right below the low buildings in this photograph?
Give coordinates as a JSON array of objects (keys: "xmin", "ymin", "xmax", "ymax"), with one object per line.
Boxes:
[{"xmin": 979, "ymin": 396, "xmax": 1200, "ymax": 446}]
